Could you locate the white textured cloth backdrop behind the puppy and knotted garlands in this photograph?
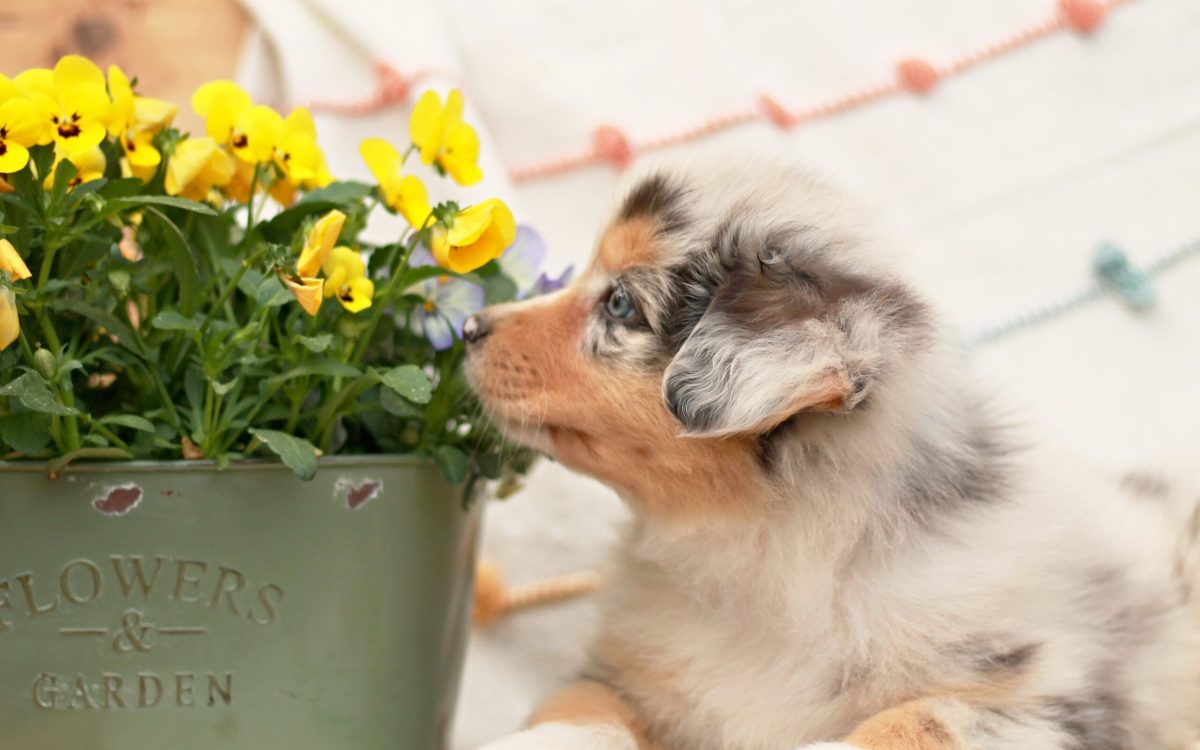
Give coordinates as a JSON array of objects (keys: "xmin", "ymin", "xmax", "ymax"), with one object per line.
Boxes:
[{"xmin": 231, "ymin": 0, "xmax": 1200, "ymax": 750}]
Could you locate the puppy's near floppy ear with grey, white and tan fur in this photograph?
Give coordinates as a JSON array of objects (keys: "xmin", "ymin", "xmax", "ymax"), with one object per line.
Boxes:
[{"xmin": 662, "ymin": 232, "xmax": 886, "ymax": 437}]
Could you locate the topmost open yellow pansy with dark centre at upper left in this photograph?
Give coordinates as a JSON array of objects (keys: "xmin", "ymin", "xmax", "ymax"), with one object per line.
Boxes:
[{"xmin": 14, "ymin": 55, "xmax": 110, "ymax": 154}]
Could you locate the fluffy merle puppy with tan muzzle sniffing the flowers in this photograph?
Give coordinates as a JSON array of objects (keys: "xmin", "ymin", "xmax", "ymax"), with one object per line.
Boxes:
[{"xmin": 464, "ymin": 159, "xmax": 1200, "ymax": 750}]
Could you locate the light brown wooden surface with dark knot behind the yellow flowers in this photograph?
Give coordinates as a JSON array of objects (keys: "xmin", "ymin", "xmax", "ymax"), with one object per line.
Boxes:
[{"xmin": 0, "ymin": 0, "xmax": 250, "ymax": 130}]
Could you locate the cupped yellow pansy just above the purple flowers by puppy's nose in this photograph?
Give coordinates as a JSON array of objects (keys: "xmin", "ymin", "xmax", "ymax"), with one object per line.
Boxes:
[{"xmin": 430, "ymin": 198, "xmax": 517, "ymax": 274}]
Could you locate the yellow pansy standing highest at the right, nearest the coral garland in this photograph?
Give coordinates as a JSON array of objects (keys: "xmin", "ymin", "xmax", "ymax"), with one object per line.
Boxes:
[{"xmin": 408, "ymin": 89, "xmax": 484, "ymax": 186}]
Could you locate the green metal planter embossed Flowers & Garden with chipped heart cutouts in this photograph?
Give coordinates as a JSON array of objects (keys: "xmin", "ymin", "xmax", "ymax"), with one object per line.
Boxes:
[{"xmin": 0, "ymin": 456, "xmax": 481, "ymax": 750}]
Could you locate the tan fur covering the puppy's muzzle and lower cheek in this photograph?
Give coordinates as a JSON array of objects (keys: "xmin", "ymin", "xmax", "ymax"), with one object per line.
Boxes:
[{"xmin": 473, "ymin": 278, "xmax": 767, "ymax": 517}]
